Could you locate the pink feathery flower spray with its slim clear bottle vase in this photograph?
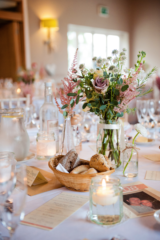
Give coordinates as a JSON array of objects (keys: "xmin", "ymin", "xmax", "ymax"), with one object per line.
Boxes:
[{"xmin": 54, "ymin": 49, "xmax": 84, "ymax": 154}]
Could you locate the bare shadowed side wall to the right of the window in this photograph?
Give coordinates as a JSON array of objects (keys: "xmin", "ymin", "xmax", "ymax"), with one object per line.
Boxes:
[{"xmin": 130, "ymin": 0, "xmax": 160, "ymax": 68}]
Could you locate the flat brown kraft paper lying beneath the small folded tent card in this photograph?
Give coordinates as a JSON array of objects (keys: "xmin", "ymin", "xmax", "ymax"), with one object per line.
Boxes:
[{"xmin": 27, "ymin": 166, "xmax": 63, "ymax": 196}]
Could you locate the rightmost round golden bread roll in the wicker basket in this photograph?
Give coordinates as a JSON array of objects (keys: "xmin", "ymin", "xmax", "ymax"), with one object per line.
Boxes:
[{"xmin": 89, "ymin": 154, "xmax": 111, "ymax": 172}]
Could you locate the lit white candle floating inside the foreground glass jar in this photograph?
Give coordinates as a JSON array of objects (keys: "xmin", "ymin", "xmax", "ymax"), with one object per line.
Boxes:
[{"xmin": 92, "ymin": 179, "xmax": 118, "ymax": 206}]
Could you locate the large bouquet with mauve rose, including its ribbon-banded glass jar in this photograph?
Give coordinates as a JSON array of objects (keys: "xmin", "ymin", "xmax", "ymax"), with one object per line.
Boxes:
[{"xmin": 77, "ymin": 49, "xmax": 155, "ymax": 167}]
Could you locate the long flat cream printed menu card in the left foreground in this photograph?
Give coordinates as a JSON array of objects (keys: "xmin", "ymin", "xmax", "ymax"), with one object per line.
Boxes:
[{"xmin": 21, "ymin": 192, "xmax": 89, "ymax": 230}]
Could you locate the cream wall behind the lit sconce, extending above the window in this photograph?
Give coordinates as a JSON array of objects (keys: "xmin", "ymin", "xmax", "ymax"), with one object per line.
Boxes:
[{"xmin": 28, "ymin": 0, "xmax": 130, "ymax": 80}]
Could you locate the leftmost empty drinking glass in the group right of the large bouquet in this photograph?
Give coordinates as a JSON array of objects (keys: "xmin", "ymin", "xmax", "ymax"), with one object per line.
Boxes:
[{"xmin": 136, "ymin": 100, "xmax": 148, "ymax": 125}]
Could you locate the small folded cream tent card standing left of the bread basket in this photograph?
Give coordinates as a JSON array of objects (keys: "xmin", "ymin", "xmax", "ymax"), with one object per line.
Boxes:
[{"xmin": 26, "ymin": 166, "xmax": 48, "ymax": 187}]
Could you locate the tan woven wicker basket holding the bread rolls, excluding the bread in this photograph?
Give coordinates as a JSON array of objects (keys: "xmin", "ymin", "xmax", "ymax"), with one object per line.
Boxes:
[{"xmin": 48, "ymin": 155, "xmax": 115, "ymax": 192}]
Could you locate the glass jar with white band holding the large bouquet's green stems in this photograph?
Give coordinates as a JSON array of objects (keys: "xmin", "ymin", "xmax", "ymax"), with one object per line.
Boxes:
[{"xmin": 97, "ymin": 120, "xmax": 121, "ymax": 168}]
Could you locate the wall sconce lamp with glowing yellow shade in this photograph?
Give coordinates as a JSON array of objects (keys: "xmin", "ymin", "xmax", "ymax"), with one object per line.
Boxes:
[{"xmin": 41, "ymin": 18, "xmax": 59, "ymax": 51}]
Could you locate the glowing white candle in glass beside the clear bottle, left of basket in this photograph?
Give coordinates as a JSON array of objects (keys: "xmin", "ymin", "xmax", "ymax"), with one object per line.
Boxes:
[{"xmin": 37, "ymin": 140, "xmax": 56, "ymax": 156}]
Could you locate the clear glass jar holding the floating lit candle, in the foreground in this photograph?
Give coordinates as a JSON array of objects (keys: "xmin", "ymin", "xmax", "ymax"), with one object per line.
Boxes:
[{"xmin": 89, "ymin": 176, "xmax": 123, "ymax": 225}]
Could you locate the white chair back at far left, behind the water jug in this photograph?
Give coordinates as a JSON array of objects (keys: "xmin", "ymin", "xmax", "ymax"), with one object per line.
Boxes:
[{"xmin": 0, "ymin": 94, "xmax": 30, "ymax": 109}]
